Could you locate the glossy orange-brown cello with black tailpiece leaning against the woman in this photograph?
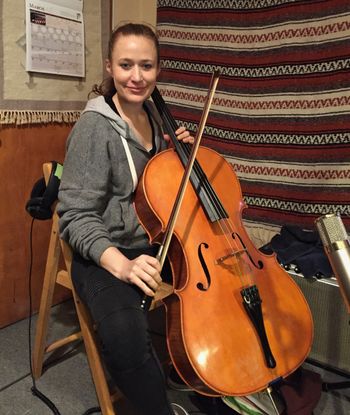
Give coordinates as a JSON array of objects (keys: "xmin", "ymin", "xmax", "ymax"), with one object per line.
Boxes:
[{"xmin": 134, "ymin": 74, "xmax": 313, "ymax": 396}]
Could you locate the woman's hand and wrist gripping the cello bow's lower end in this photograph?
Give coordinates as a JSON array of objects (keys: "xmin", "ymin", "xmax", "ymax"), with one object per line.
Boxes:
[{"xmin": 100, "ymin": 247, "xmax": 162, "ymax": 297}]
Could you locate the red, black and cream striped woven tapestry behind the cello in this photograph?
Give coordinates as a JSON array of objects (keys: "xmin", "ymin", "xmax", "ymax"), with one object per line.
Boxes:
[{"xmin": 157, "ymin": 0, "xmax": 350, "ymax": 246}]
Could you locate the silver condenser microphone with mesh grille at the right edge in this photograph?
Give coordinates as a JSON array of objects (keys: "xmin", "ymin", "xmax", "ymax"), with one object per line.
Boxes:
[{"xmin": 315, "ymin": 213, "xmax": 350, "ymax": 313}]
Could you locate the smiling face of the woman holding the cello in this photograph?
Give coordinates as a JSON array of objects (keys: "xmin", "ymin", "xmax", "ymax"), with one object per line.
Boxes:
[{"xmin": 106, "ymin": 35, "xmax": 159, "ymax": 104}]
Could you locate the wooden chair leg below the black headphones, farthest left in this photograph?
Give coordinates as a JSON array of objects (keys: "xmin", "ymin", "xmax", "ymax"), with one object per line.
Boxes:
[{"xmin": 33, "ymin": 215, "xmax": 61, "ymax": 379}]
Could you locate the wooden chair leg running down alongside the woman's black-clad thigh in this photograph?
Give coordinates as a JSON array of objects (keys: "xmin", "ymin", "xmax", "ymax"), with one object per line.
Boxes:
[{"xmin": 72, "ymin": 288, "xmax": 116, "ymax": 415}]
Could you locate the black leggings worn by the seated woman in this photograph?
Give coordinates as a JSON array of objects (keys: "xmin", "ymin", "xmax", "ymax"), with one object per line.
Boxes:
[{"xmin": 72, "ymin": 250, "xmax": 173, "ymax": 415}]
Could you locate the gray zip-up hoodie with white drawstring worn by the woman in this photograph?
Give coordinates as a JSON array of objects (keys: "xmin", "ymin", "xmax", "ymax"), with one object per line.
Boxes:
[{"xmin": 57, "ymin": 96, "xmax": 166, "ymax": 264}]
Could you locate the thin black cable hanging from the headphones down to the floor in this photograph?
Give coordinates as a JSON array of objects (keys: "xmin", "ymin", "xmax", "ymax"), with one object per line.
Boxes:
[{"xmin": 28, "ymin": 218, "xmax": 61, "ymax": 415}]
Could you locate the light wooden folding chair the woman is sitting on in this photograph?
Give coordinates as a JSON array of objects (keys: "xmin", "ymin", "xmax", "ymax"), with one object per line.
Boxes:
[{"xmin": 32, "ymin": 163, "xmax": 173, "ymax": 415}]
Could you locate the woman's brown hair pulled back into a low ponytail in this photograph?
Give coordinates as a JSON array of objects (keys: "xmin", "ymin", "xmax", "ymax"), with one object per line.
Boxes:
[{"xmin": 89, "ymin": 23, "xmax": 160, "ymax": 95}]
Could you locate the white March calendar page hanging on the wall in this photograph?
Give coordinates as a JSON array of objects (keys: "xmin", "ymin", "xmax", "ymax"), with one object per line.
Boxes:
[{"xmin": 26, "ymin": 0, "xmax": 85, "ymax": 77}]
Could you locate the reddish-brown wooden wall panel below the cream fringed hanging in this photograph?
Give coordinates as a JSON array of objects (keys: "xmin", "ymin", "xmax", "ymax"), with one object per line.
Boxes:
[{"xmin": 0, "ymin": 124, "xmax": 71, "ymax": 328}]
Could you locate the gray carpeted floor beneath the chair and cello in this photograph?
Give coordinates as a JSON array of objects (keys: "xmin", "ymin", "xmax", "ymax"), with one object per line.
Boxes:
[{"xmin": 0, "ymin": 301, "xmax": 350, "ymax": 415}]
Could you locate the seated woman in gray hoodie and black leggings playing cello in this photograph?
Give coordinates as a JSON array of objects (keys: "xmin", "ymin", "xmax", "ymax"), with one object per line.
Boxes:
[{"xmin": 58, "ymin": 23, "xmax": 193, "ymax": 415}]
